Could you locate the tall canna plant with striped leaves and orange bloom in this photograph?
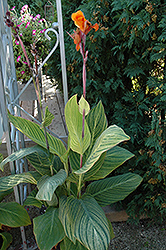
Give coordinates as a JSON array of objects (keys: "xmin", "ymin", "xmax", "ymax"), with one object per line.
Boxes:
[{"xmin": 0, "ymin": 10, "xmax": 142, "ymax": 250}]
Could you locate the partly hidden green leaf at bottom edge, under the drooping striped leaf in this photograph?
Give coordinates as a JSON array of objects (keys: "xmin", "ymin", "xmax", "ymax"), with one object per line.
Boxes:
[{"xmin": 60, "ymin": 237, "xmax": 87, "ymax": 250}]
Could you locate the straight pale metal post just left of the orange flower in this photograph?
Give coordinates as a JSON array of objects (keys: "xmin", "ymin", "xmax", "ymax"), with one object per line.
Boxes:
[{"xmin": 56, "ymin": 0, "xmax": 68, "ymax": 104}]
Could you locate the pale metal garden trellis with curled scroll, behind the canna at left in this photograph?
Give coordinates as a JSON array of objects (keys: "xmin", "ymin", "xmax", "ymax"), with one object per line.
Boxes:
[{"xmin": 0, "ymin": 0, "xmax": 68, "ymax": 249}]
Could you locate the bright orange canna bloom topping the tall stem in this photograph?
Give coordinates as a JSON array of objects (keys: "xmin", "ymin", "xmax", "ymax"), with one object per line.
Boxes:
[{"xmin": 71, "ymin": 10, "xmax": 99, "ymax": 35}]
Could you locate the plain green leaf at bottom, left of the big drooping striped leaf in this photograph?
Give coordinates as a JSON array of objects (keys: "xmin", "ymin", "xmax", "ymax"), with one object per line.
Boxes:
[{"xmin": 33, "ymin": 208, "xmax": 65, "ymax": 250}]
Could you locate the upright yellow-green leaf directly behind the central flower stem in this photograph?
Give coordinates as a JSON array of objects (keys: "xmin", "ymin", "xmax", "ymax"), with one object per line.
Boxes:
[{"xmin": 65, "ymin": 95, "xmax": 91, "ymax": 155}]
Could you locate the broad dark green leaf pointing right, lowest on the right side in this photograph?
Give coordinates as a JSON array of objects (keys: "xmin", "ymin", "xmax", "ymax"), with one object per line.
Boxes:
[{"xmin": 86, "ymin": 173, "xmax": 142, "ymax": 207}]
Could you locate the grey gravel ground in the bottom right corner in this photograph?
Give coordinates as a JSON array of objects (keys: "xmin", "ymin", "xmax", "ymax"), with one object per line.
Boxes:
[{"xmin": 109, "ymin": 220, "xmax": 166, "ymax": 250}]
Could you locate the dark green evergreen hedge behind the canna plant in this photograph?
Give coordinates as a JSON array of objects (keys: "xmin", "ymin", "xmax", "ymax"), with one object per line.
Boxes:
[{"xmin": 45, "ymin": 0, "xmax": 166, "ymax": 223}]
